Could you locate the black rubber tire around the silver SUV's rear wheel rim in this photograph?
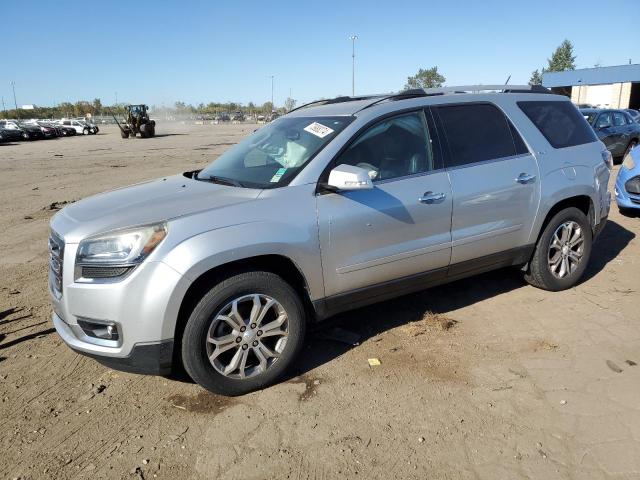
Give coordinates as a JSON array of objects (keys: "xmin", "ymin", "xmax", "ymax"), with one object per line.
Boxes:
[{"xmin": 525, "ymin": 207, "xmax": 593, "ymax": 292}]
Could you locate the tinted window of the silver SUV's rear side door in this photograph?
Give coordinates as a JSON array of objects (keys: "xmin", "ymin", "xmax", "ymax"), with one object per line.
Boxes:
[{"xmin": 434, "ymin": 104, "xmax": 526, "ymax": 166}]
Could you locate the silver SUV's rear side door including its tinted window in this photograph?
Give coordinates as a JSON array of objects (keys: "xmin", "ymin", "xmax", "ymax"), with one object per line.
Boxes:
[{"xmin": 433, "ymin": 103, "xmax": 540, "ymax": 268}]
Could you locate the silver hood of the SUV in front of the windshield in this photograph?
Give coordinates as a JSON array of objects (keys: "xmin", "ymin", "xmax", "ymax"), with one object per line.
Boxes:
[{"xmin": 51, "ymin": 175, "xmax": 261, "ymax": 243}]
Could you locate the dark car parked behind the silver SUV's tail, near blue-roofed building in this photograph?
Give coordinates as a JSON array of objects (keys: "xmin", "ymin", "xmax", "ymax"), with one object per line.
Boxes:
[{"xmin": 580, "ymin": 108, "xmax": 640, "ymax": 160}]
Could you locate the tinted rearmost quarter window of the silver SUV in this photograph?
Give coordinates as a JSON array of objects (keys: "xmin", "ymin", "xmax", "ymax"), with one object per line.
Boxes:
[{"xmin": 518, "ymin": 100, "xmax": 597, "ymax": 148}]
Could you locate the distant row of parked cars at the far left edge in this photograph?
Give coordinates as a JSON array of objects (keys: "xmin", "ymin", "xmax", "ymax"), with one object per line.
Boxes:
[{"xmin": 0, "ymin": 118, "xmax": 100, "ymax": 143}]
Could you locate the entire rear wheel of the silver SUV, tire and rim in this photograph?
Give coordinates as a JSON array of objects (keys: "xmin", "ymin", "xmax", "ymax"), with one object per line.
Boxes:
[{"xmin": 525, "ymin": 207, "xmax": 593, "ymax": 291}]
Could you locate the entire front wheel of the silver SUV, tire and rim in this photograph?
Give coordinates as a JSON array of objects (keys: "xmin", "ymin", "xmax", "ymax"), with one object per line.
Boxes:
[{"xmin": 182, "ymin": 272, "xmax": 305, "ymax": 395}]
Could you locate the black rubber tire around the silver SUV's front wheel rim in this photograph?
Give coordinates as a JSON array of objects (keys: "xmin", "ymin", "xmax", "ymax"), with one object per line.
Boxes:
[{"xmin": 182, "ymin": 272, "xmax": 306, "ymax": 396}]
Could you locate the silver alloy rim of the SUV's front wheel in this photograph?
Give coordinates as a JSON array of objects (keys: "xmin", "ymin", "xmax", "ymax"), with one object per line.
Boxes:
[{"xmin": 206, "ymin": 293, "xmax": 289, "ymax": 379}]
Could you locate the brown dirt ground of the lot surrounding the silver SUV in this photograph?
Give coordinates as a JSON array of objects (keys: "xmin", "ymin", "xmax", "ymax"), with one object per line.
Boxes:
[{"xmin": 0, "ymin": 124, "xmax": 640, "ymax": 479}]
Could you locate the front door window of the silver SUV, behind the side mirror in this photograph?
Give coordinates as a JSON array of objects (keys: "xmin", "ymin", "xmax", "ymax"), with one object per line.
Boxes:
[{"xmin": 336, "ymin": 111, "xmax": 433, "ymax": 181}]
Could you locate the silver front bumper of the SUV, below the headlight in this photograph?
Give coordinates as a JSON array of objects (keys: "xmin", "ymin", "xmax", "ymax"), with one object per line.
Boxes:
[{"xmin": 50, "ymin": 244, "xmax": 189, "ymax": 375}]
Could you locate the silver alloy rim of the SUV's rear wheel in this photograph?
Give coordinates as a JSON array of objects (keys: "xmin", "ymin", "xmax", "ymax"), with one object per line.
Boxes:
[{"xmin": 547, "ymin": 220, "xmax": 584, "ymax": 278}]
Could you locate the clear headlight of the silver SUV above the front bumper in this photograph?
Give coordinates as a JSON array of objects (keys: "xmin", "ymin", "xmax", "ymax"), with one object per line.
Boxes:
[{"xmin": 76, "ymin": 223, "xmax": 167, "ymax": 267}]
